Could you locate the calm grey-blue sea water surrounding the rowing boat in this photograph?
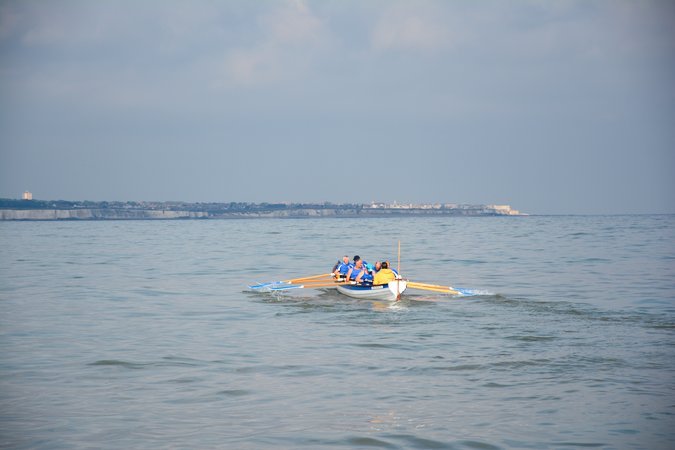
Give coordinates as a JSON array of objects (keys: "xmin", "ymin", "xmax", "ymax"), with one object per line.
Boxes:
[{"xmin": 0, "ymin": 216, "xmax": 675, "ymax": 449}]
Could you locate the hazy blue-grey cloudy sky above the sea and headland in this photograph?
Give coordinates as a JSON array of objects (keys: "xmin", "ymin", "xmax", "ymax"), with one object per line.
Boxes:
[{"xmin": 0, "ymin": 0, "xmax": 675, "ymax": 214}]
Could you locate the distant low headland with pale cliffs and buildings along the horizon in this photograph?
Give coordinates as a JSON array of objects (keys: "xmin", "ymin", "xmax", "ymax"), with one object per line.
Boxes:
[{"xmin": 0, "ymin": 194, "xmax": 526, "ymax": 220}]
